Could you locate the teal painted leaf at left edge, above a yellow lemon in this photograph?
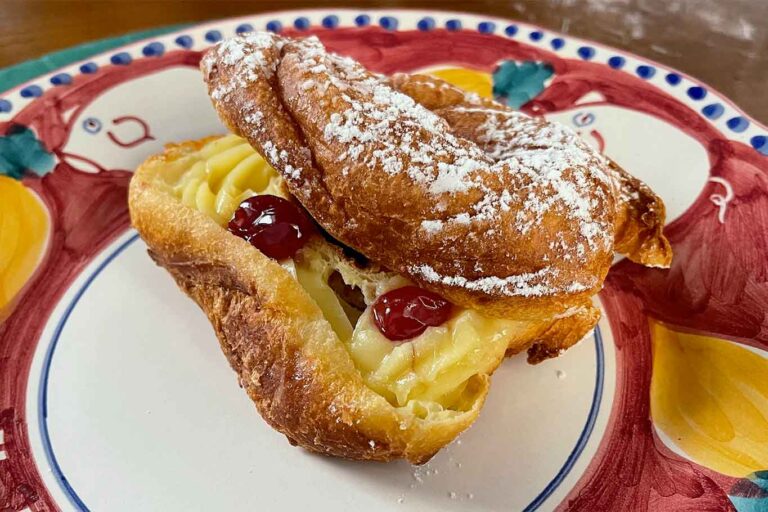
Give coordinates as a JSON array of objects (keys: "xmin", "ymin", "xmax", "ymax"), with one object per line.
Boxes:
[{"xmin": 0, "ymin": 125, "xmax": 54, "ymax": 180}]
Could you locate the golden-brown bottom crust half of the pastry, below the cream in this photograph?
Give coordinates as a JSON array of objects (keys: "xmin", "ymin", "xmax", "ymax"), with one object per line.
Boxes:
[{"xmin": 129, "ymin": 141, "xmax": 489, "ymax": 463}]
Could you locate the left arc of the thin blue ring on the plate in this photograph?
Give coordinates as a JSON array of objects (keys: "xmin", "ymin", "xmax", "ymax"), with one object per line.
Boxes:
[{"xmin": 37, "ymin": 234, "xmax": 139, "ymax": 512}]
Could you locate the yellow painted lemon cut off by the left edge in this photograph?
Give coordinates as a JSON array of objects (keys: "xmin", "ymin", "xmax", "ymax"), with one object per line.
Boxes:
[{"xmin": 0, "ymin": 176, "xmax": 49, "ymax": 321}]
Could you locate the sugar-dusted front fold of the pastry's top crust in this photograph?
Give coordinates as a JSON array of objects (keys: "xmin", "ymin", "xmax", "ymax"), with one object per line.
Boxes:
[{"xmin": 202, "ymin": 34, "xmax": 614, "ymax": 320}]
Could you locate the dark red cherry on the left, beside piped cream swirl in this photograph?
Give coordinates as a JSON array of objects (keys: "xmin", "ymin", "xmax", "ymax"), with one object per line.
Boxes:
[{"xmin": 228, "ymin": 195, "xmax": 314, "ymax": 260}]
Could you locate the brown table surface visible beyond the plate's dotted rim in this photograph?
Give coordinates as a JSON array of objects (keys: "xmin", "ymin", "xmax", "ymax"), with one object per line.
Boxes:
[{"xmin": 0, "ymin": 0, "xmax": 768, "ymax": 123}]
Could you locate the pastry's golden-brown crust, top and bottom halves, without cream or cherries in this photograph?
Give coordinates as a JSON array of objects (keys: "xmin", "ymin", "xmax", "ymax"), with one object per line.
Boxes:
[{"xmin": 129, "ymin": 28, "xmax": 671, "ymax": 463}]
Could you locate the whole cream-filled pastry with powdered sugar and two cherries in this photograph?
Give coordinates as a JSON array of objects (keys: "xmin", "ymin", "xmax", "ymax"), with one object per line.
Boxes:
[{"xmin": 129, "ymin": 33, "xmax": 672, "ymax": 463}]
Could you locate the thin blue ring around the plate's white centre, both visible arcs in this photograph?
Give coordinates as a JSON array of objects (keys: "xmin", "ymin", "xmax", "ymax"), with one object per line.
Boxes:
[{"xmin": 38, "ymin": 234, "xmax": 605, "ymax": 512}]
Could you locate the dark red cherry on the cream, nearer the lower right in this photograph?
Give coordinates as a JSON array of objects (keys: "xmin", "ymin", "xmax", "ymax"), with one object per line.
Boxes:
[{"xmin": 371, "ymin": 286, "xmax": 452, "ymax": 341}]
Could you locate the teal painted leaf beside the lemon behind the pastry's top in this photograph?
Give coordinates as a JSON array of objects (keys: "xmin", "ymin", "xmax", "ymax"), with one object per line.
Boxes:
[{"xmin": 493, "ymin": 60, "xmax": 554, "ymax": 108}]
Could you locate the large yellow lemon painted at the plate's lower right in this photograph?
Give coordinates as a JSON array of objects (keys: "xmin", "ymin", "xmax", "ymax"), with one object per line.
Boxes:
[{"xmin": 651, "ymin": 320, "xmax": 768, "ymax": 477}]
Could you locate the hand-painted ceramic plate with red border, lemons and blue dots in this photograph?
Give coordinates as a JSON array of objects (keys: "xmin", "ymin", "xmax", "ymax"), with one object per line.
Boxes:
[{"xmin": 0, "ymin": 10, "xmax": 768, "ymax": 512}]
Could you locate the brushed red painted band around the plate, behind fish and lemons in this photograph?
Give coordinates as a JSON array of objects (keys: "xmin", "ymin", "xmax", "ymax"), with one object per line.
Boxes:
[{"xmin": 0, "ymin": 27, "xmax": 768, "ymax": 511}]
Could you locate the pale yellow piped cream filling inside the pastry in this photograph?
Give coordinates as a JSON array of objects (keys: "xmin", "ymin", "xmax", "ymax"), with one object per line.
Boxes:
[{"xmin": 164, "ymin": 135, "xmax": 518, "ymax": 418}]
